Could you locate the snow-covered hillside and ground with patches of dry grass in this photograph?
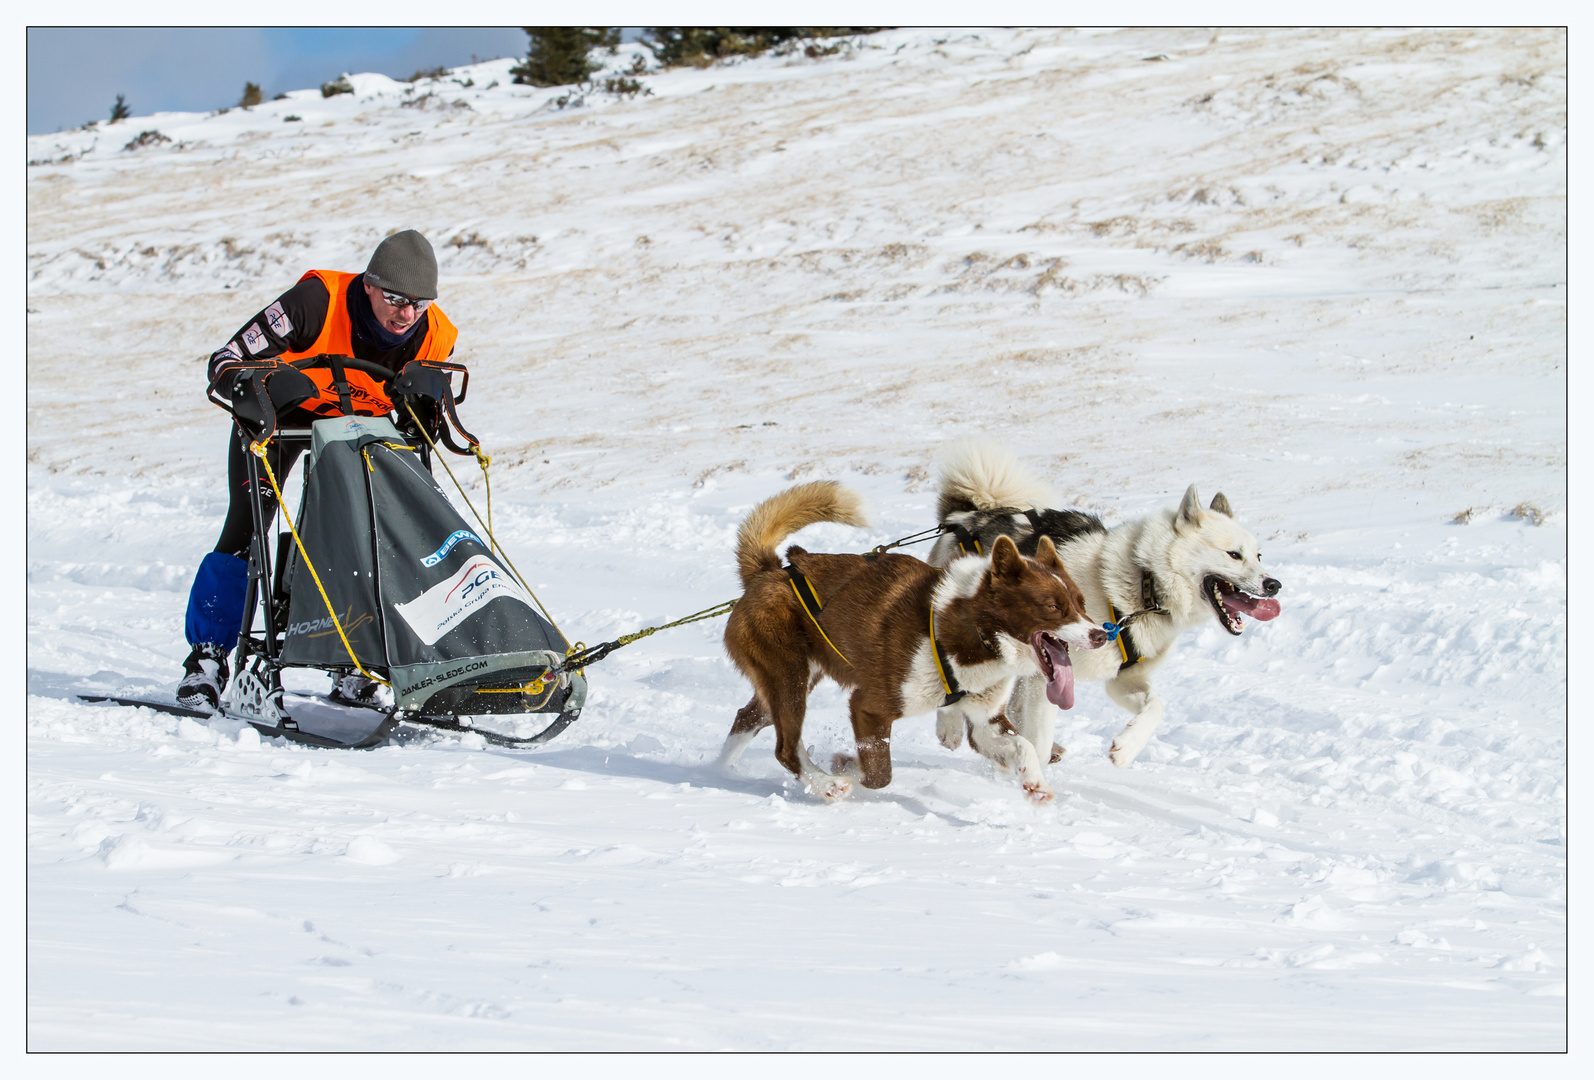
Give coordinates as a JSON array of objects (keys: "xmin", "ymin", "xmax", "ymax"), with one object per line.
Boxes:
[{"xmin": 27, "ymin": 30, "xmax": 1567, "ymax": 1050}]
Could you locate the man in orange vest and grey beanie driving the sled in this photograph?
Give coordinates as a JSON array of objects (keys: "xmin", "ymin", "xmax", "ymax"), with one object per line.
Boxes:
[{"xmin": 177, "ymin": 229, "xmax": 457, "ymax": 709}]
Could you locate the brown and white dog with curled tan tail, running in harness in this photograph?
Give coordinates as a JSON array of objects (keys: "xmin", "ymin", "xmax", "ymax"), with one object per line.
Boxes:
[{"xmin": 720, "ymin": 481, "xmax": 1106, "ymax": 801}]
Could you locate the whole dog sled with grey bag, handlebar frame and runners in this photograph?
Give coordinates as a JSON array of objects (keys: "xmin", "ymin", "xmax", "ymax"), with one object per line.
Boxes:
[{"xmin": 86, "ymin": 357, "xmax": 587, "ymax": 749}]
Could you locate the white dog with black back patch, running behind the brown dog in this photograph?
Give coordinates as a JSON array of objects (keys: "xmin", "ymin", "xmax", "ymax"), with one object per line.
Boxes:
[{"xmin": 928, "ymin": 438, "xmax": 1283, "ymax": 766}]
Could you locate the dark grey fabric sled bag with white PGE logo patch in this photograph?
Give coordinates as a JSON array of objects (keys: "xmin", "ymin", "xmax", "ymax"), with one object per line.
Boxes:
[{"xmin": 282, "ymin": 416, "xmax": 585, "ymax": 714}]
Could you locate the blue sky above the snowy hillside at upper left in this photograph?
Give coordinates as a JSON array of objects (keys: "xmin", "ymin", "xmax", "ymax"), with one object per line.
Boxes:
[{"xmin": 27, "ymin": 27, "xmax": 526, "ymax": 134}]
